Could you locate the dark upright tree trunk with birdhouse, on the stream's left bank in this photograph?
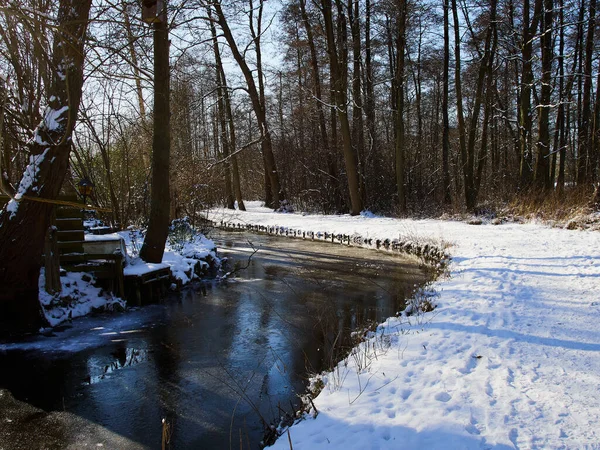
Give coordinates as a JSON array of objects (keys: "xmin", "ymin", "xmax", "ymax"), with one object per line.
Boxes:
[{"xmin": 140, "ymin": 6, "xmax": 171, "ymax": 263}]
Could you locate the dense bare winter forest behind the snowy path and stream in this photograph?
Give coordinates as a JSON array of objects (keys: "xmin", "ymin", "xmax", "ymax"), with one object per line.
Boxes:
[{"xmin": 0, "ymin": 0, "xmax": 600, "ymax": 221}]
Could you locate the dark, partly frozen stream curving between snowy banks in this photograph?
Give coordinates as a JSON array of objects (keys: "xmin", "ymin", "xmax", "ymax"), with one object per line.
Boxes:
[{"xmin": 0, "ymin": 232, "xmax": 429, "ymax": 449}]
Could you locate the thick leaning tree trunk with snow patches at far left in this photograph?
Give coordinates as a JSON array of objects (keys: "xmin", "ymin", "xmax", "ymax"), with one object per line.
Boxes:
[{"xmin": 0, "ymin": 0, "xmax": 91, "ymax": 333}]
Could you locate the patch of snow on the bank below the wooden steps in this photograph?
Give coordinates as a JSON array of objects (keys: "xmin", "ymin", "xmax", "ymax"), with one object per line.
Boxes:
[{"xmin": 39, "ymin": 268, "xmax": 125, "ymax": 327}]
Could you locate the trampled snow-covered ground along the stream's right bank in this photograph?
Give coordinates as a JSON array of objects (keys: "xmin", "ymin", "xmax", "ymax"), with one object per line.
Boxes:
[{"xmin": 210, "ymin": 202, "xmax": 600, "ymax": 450}]
